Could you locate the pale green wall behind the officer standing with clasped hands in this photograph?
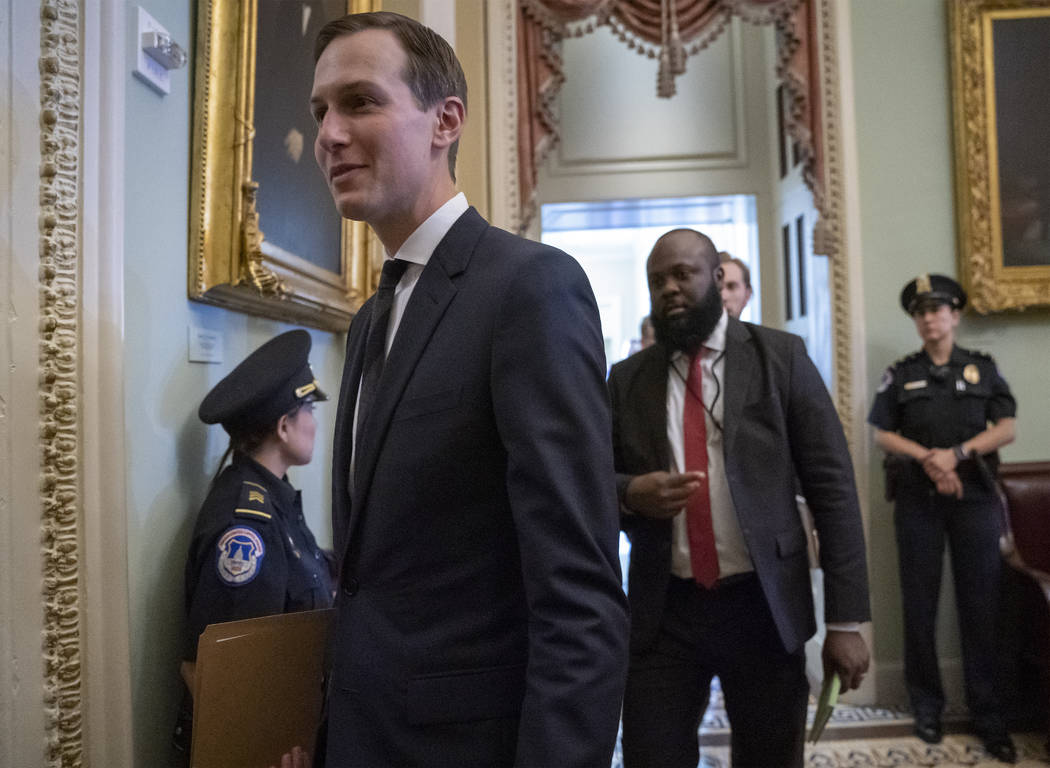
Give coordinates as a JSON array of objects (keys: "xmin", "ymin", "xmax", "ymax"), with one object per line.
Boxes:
[{"xmin": 849, "ymin": 0, "xmax": 1050, "ymax": 703}]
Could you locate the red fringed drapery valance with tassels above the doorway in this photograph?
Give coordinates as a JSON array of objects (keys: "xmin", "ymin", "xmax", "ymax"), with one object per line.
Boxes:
[{"xmin": 518, "ymin": 0, "xmax": 823, "ymax": 230}]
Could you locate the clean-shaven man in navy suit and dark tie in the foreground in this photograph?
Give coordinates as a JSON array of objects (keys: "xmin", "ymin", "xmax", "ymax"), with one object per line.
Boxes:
[{"xmin": 311, "ymin": 13, "xmax": 627, "ymax": 768}]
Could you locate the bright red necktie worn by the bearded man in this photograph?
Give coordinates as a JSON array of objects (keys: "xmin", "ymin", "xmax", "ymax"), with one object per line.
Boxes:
[{"xmin": 683, "ymin": 355, "xmax": 718, "ymax": 588}]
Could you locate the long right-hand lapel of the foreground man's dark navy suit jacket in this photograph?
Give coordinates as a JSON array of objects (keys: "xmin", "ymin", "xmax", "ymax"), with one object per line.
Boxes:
[{"xmin": 351, "ymin": 208, "xmax": 488, "ymax": 532}]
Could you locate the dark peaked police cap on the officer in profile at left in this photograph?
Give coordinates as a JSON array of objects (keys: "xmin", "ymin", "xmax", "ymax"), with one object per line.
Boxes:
[{"xmin": 197, "ymin": 330, "xmax": 328, "ymax": 435}]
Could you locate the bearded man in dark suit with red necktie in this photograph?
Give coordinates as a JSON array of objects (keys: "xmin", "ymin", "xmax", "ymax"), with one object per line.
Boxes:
[{"xmin": 609, "ymin": 229, "xmax": 869, "ymax": 768}]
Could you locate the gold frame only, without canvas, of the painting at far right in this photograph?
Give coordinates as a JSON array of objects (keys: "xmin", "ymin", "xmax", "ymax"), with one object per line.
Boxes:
[{"xmin": 948, "ymin": 0, "xmax": 1050, "ymax": 313}]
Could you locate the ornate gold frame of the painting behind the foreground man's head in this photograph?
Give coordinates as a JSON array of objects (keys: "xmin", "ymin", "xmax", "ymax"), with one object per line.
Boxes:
[{"xmin": 189, "ymin": 0, "xmax": 380, "ymax": 332}]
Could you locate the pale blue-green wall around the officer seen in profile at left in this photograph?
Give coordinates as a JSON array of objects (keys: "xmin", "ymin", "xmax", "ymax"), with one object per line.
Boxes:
[{"xmin": 124, "ymin": 0, "xmax": 345, "ymax": 767}]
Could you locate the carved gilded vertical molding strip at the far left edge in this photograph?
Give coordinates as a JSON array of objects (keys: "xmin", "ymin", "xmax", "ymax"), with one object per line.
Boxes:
[{"xmin": 39, "ymin": 0, "xmax": 83, "ymax": 766}]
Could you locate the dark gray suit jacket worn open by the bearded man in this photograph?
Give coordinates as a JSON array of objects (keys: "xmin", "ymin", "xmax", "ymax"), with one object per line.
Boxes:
[{"xmin": 609, "ymin": 318, "xmax": 870, "ymax": 651}]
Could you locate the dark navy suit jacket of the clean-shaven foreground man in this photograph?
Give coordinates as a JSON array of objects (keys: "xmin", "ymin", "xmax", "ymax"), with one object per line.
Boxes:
[{"xmin": 328, "ymin": 209, "xmax": 628, "ymax": 768}]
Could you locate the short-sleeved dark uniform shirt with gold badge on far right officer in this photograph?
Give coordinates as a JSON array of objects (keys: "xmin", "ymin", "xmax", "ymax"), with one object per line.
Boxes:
[{"xmin": 867, "ymin": 347, "xmax": 1016, "ymax": 490}]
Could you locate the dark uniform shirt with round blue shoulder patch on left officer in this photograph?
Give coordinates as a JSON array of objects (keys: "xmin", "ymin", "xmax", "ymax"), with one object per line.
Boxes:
[{"xmin": 186, "ymin": 453, "xmax": 333, "ymax": 659}]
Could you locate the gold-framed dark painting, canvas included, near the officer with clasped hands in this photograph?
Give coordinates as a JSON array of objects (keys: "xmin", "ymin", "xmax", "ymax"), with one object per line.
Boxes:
[{"xmin": 948, "ymin": 0, "xmax": 1050, "ymax": 313}]
